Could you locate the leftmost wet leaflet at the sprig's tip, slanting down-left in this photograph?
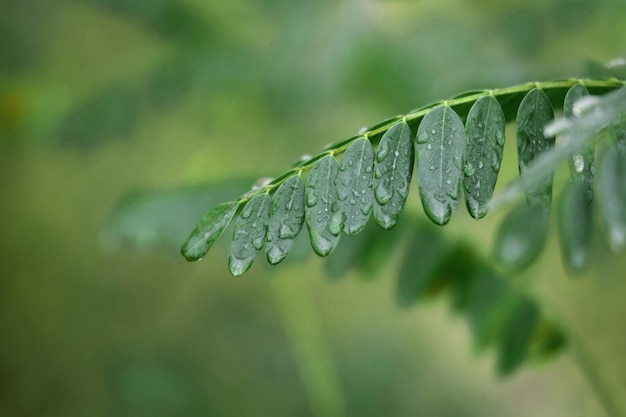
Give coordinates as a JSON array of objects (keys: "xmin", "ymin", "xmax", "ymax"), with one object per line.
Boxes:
[{"xmin": 181, "ymin": 201, "xmax": 239, "ymax": 261}]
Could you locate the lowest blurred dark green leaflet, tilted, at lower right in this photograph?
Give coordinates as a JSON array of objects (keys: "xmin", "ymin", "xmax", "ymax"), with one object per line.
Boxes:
[{"xmin": 498, "ymin": 298, "xmax": 541, "ymax": 375}]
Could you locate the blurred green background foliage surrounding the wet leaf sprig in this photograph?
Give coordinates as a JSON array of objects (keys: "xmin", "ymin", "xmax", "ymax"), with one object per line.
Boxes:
[{"xmin": 0, "ymin": 0, "xmax": 626, "ymax": 417}]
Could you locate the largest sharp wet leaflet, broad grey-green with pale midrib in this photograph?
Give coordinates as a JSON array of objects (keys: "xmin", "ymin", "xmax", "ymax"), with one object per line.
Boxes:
[{"xmin": 416, "ymin": 104, "xmax": 466, "ymax": 225}]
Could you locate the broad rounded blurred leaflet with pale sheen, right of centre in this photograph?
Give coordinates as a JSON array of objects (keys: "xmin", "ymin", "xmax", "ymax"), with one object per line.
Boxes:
[{"xmin": 494, "ymin": 204, "xmax": 550, "ymax": 272}]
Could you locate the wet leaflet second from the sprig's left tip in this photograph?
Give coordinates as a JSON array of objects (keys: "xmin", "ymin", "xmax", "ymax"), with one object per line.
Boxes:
[{"xmin": 228, "ymin": 193, "xmax": 271, "ymax": 276}]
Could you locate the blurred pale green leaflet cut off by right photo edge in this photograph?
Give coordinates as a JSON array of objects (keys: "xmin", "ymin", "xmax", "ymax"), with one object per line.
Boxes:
[{"xmin": 596, "ymin": 137, "xmax": 626, "ymax": 253}]
